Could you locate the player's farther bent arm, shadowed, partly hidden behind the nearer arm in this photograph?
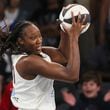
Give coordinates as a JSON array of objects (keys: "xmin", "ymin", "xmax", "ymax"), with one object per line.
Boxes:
[{"xmin": 42, "ymin": 31, "xmax": 69, "ymax": 65}]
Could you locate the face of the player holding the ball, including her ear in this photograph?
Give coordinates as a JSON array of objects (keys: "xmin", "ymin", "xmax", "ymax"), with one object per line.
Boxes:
[{"xmin": 18, "ymin": 25, "xmax": 42, "ymax": 53}]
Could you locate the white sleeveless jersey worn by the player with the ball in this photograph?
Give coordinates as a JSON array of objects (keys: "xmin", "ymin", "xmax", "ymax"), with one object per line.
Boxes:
[{"xmin": 11, "ymin": 54, "xmax": 55, "ymax": 110}]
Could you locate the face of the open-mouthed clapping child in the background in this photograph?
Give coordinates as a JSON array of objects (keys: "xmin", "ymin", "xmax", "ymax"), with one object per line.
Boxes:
[{"xmin": 82, "ymin": 80, "xmax": 100, "ymax": 98}]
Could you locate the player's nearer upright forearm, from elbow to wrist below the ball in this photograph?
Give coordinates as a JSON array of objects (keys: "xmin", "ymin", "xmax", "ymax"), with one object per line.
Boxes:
[{"xmin": 67, "ymin": 37, "xmax": 80, "ymax": 81}]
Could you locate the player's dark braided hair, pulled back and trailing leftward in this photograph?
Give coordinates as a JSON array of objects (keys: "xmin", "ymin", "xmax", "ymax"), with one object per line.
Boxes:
[{"xmin": 0, "ymin": 21, "xmax": 32, "ymax": 56}]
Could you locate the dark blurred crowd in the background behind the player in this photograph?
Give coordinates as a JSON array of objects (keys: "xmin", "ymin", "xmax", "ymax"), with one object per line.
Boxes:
[{"xmin": 0, "ymin": 0, "xmax": 110, "ymax": 110}]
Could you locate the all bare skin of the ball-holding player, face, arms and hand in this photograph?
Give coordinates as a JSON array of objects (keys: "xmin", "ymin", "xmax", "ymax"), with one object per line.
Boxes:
[{"xmin": 16, "ymin": 14, "xmax": 85, "ymax": 83}]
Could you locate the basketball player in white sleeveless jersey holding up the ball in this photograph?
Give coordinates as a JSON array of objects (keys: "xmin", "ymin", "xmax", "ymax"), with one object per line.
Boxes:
[{"xmin": 1, "ymin": 14, "xmax": 85, "ymax": 110}]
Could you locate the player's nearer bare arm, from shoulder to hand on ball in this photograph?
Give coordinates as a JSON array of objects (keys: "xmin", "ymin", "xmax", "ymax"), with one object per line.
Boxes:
[{"xmin": 17, "ymin": 12, "xmax": 82, "ymax": 82}]
